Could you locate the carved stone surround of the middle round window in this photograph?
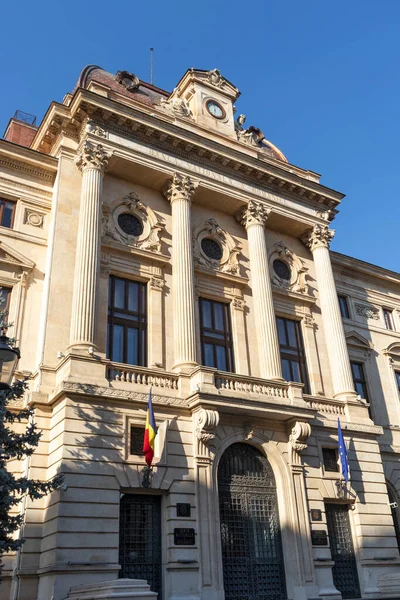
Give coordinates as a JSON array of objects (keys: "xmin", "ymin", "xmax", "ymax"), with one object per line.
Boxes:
[{"xmin": 193, "ymin": 218, "xmax": 241, "ymax": 275}]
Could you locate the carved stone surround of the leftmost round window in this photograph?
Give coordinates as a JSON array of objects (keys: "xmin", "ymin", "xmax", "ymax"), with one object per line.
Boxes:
[{"xmin": 101, "ymin": 192, "xmax": 165, "ymax": 253}]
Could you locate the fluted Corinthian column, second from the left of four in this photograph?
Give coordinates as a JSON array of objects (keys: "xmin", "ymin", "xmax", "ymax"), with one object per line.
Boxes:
[{"xmin": 165, "ymin": 173, "xmax": 198, "ymax": 369}]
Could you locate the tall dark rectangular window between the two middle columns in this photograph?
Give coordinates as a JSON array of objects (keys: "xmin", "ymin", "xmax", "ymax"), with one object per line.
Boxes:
[{"xmin": 199, "ymin": 298, "xmax": 234, "ymax": 372}]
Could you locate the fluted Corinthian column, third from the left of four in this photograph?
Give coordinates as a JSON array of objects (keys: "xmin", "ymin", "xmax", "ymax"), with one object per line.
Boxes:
[{"xmin": 237, "ymin": 200, "xmax": 282, "ymax": 379}]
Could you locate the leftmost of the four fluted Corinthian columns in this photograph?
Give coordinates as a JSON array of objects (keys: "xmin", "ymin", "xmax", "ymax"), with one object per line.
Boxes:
[{"xmin": 70, "ymin": 142, "xmax": 111, "ymax": 348}]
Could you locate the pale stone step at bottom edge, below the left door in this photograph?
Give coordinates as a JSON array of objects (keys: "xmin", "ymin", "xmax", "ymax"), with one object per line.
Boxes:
[{"xmin": 65, "ymin": 579, "xmax": 157, "ymax": 600}]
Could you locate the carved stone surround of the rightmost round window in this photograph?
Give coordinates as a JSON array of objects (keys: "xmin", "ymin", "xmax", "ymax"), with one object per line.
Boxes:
[{"xmin": 269, "ymin": 242, "xmax": 308, "ymax": 294}]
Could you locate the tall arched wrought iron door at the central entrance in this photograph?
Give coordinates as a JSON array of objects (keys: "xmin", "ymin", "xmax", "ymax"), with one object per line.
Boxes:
[{"xmin": 218, "ymin": 443, "xmax": 286, "ymax": 600}]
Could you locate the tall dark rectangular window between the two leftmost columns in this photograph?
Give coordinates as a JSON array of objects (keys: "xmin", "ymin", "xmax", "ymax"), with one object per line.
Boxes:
[{"xmin": 107, "ymin": 276, "xmax": 147, "ymax": 367}]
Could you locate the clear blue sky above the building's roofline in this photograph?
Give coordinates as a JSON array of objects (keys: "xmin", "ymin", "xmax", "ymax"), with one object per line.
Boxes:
[{"xmin": 0, "ymin": 0, "xmax": 400, "ymax": 271}]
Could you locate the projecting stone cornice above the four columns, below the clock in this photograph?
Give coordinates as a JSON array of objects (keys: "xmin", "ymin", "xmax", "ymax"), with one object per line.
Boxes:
[{"xmin": 34, "ymin": 89, "xmax": 343, "ymax": 212}]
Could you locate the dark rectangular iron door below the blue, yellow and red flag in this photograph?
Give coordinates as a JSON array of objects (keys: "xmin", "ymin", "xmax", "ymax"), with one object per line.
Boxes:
[{"xmin": 119, "ymin": 494, "xmax": 162, "ymax": 600}]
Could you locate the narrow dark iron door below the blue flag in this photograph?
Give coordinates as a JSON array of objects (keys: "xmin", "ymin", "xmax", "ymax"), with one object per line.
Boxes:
[{"xmin": 325, "ymin": 504, "xmax": 361, "ymax": 598}]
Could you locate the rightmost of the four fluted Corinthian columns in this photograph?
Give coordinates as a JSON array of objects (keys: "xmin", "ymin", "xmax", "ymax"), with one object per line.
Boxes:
[{"xmin": 303, "ymin": 225, "xmax": 356, "ymax": 398}]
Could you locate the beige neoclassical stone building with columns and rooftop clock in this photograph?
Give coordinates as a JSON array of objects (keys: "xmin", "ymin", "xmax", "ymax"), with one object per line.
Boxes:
[{"xmin": 0, "ymin": 66, "xmax": 400, "ymax": 600}]
